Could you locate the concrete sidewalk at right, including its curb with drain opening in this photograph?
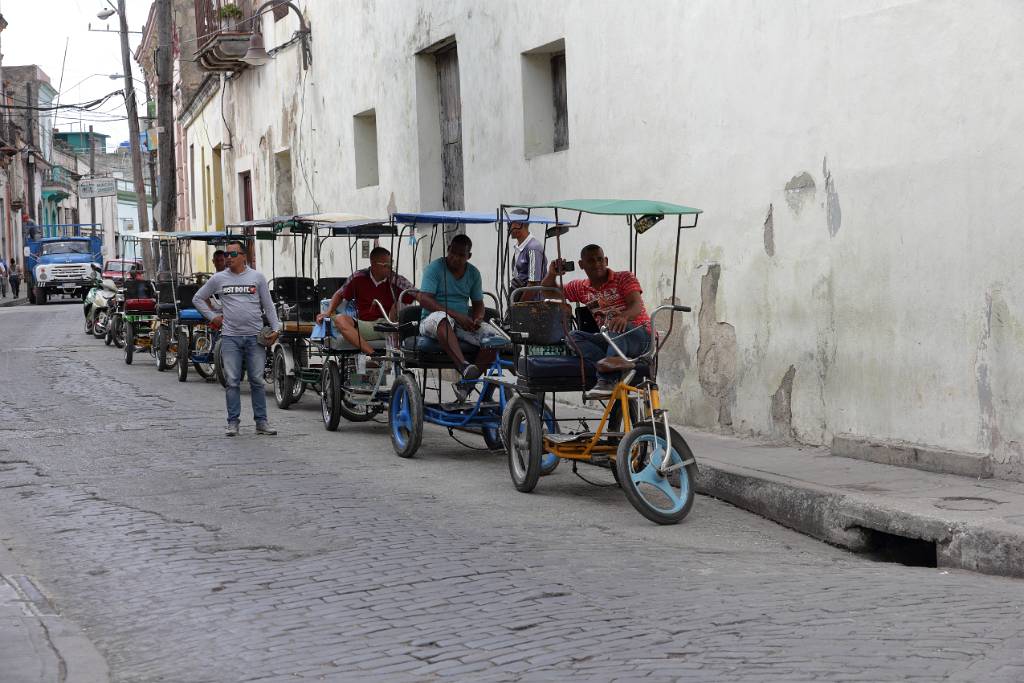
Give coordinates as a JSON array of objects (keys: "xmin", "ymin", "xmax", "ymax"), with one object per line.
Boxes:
[{"xmin": 683, "ymin": 429, "xmax": 1024, "ymax": 578}]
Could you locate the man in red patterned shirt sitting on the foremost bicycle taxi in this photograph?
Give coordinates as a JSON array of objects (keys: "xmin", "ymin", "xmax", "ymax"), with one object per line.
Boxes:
[{"xmin": 541, "ymin": 245, "xmax": 651, "ymax": 399}]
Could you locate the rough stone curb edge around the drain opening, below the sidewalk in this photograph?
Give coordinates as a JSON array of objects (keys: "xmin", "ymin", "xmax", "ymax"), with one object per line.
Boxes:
[{"xmin": 697, "ymin": 459, "xmax": 1024, "ymax": 578}]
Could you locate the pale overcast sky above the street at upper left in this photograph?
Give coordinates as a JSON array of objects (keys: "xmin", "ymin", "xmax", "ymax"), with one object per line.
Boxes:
[{"xmin": 0, "ymin": 0, "xmax": 152, "ymax": 150}]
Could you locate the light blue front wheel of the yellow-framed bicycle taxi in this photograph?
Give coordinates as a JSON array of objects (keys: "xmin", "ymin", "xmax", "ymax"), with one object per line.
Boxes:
[{"xmin": 615, "ymin": 423, "xmax": 697, "ymax": 524}]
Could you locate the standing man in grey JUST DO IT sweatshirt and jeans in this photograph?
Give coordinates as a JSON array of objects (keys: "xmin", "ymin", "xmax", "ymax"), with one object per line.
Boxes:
[{"xmin": 193, "ymin": 242, "xmax": 281, "ymax": 436}]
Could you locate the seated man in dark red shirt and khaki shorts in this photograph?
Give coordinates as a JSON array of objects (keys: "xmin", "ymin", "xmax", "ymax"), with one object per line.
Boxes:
[{"xmin": 316, "ymin": 247, "xmax": 413, "ymax": 368}]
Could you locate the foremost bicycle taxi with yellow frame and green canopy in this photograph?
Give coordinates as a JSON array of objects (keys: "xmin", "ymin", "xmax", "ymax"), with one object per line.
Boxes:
[{"xmin": 501, "ymin": 200, "xmax": 701, "ymax": 524}]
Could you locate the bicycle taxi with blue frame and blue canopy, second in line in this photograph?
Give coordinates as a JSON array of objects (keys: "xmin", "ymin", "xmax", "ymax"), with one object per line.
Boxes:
[{"xmin": 379, "ymin": 211, "xmax": 558, "ymax": 462}]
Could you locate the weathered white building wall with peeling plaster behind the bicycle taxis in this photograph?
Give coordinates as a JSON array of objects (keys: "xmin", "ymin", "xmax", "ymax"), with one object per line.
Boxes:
[{"xmin": 188, "ymin": 0, "xmax": 1024, "ymax": 464}]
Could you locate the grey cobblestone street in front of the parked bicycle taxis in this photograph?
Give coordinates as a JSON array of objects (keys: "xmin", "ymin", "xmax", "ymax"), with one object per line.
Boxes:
[{"xmin": 0, "ymin": 303, "xmax": 1024, "ymax": 683}]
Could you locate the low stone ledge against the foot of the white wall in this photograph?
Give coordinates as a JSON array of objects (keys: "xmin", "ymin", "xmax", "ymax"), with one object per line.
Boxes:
[{"xmin": 831, "ymin": 434, "xmax": 994, "ymax": 479}]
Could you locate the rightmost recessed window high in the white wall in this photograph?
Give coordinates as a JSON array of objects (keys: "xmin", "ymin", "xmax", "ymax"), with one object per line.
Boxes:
[{"xmin": 522, "ymin": 40, "xmax": 569, "ymax": 159}]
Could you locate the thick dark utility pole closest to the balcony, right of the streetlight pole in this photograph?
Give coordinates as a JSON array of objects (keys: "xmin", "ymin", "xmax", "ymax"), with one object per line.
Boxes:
[{"xmin": 152, "ymin": 0, "xmax": 178, "ymax": 230}]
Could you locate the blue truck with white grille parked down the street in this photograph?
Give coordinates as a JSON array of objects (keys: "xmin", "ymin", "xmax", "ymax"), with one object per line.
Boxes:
[{"xmin": 25, "ymin": 225, "xmax": 103, "ymax": 304}]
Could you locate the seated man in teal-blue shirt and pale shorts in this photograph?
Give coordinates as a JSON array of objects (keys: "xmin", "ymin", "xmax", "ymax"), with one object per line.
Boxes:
[{"xmin": 419, "ymin": 234, "xmax": 497, "ymax": 380}]
